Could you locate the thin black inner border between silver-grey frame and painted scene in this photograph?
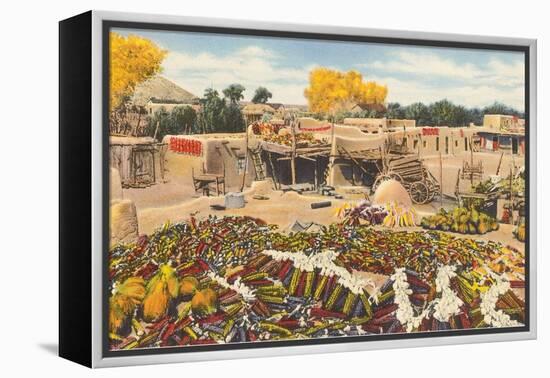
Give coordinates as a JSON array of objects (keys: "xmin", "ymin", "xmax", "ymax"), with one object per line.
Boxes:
[{"xmin": 101, "ymin": 20, "xmax": 531, "ymax": 358}]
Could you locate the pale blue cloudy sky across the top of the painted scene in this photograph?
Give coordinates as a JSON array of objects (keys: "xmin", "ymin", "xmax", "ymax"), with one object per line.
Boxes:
[{"xmin": 114, "ymin": 29, "xmax": 524, "ymax": 111}]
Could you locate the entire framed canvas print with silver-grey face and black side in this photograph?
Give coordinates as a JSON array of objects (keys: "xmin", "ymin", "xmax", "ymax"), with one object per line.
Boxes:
[{"xmin": 59, "ymin": 11, "xmax": 536, "ymax": 367}]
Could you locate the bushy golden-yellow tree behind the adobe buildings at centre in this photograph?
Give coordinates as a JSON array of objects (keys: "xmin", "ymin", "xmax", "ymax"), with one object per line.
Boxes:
[{"xmin": 304, "ymin": 67, "xmax": 388, "ymax": 113}]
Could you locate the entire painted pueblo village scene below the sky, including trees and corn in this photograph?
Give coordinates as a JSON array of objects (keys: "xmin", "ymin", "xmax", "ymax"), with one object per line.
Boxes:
[{"xmin": 106, "ymin": 31, "xmax": 529, "ymax": 350}]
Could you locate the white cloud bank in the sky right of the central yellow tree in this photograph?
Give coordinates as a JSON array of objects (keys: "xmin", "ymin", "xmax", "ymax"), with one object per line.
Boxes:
[{"xmin": 360, "ymin": 51, "xmax": 525, "ymax": 110}]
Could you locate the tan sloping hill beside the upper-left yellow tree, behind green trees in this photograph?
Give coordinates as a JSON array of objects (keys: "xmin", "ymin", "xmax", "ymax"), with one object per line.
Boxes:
[{"xmin": 132, "ymin": 76, "xmax": 198, "ymax": 106}]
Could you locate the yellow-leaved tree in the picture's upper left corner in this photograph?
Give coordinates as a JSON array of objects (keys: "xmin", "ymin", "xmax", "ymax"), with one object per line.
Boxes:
[{"xmin": 109, "ymin": 32, "xmax": 167, "ymax": 110}]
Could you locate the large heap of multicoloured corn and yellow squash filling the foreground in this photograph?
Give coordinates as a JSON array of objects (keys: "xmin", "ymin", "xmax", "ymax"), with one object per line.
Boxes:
[{"xmin": 109, "ymin": 217, "xmax": 524, "ymax": 349}]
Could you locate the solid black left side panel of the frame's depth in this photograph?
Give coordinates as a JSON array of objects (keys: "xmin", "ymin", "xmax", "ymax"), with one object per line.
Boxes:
[{"xmin": 58, "ymin": 11, "xmax": 93, "ymax": 367}]
